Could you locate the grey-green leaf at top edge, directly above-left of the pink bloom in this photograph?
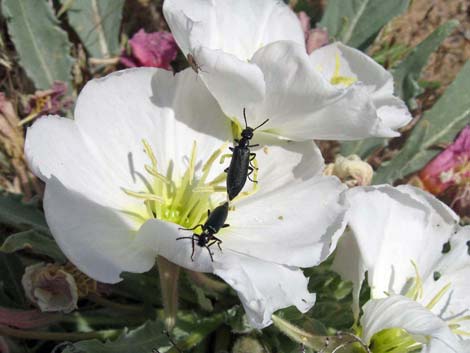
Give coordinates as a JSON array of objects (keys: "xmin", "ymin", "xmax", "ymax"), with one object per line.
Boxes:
[{"xmin": 62, "ymin": 0, "xmax": 124, "ymax": 58}]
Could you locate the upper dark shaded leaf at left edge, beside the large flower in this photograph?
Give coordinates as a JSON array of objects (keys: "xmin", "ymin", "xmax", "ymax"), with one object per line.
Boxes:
[{"xmin": 0, "ymin": 193, "xmax": 49, "ymax": 234}]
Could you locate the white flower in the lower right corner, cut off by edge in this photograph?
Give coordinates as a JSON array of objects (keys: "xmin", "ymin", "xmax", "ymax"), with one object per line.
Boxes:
[{"xmin": 333, "ymin": 186, "xmax": 470, "ymax": 353}]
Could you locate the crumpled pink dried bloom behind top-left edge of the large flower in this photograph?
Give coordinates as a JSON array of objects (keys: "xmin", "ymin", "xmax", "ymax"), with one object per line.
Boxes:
[{"xmin": 120, "ymin": 29, "xmax": 178, "ymax": 70}]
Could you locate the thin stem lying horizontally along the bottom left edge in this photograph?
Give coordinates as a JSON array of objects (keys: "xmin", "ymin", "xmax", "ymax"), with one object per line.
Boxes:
[{"xmin": 0, "ymin": 326, "xmax": 121, "ymax": 342}]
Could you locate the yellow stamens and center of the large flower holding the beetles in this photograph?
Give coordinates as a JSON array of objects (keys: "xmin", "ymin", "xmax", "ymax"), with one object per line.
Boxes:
[{"xmin": 122, "ymin": 140, "xmax": 228, "ymax": 228}]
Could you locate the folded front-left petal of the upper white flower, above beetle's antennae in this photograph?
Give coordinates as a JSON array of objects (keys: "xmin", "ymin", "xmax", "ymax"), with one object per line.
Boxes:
[{"xmin": 194, "ymin": 47, "xmax": 265, "ymax": 117}]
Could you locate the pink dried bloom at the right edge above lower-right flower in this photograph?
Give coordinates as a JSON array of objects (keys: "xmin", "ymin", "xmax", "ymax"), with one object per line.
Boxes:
[{"xmin": 419, "ymin": 125, "xmax": 470, "ymax": 195}]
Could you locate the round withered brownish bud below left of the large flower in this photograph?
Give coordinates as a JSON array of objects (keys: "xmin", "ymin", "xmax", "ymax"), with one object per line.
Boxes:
[{"xmin": 21, "ymin": 263, "xmax": 78, "ymax": 313}]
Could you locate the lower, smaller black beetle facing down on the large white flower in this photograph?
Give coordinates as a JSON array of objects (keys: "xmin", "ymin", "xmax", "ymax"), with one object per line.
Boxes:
[{"xmin": 176, "ymin": 202, "xmax": 229, "ymax": 261}]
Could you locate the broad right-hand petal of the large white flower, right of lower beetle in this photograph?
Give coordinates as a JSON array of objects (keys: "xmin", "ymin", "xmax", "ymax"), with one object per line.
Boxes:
[{"xmin": 221, "ymin": 177, "xmax": 345, "ymax": 267}]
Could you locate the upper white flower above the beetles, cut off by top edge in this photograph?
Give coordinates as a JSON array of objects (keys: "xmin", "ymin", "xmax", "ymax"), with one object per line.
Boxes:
[{"xmin": 163, "ymin": 0, "xmax": 410, "ymax": 141}]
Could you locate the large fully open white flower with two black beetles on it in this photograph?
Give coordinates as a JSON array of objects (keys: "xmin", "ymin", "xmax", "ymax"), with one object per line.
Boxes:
[{"xmin": 25, "ymin": 68, "xmax": 344, "ymax": 327}]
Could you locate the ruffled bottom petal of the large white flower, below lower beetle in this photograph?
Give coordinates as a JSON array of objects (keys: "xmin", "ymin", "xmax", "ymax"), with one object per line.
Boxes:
[{"xmin": 214, "ymin": 250, "xmax": 315, "ymax": 329}]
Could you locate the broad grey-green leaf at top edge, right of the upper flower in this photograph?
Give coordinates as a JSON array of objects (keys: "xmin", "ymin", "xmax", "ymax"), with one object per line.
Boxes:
[{"xmin": 319, "ymin": 0, "xmax": 409, "ymax": 49}]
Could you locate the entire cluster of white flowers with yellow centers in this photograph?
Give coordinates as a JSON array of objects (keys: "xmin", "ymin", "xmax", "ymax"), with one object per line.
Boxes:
[{"xmin": 25, "ymin": 0, "xmax": 470, "ymax": 352}]
